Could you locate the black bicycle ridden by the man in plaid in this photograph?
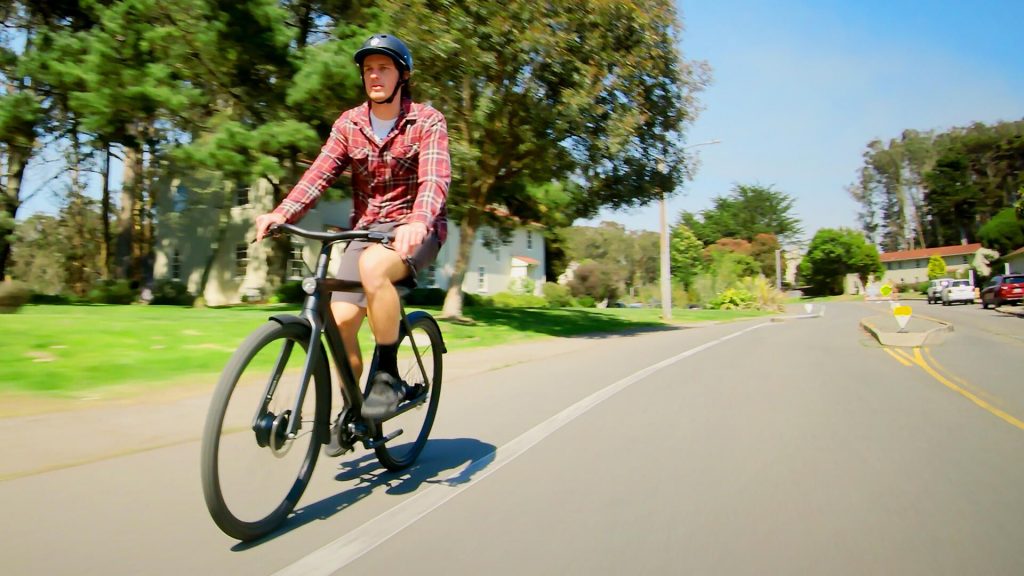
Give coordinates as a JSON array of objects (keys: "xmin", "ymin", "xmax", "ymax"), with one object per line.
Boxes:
[{"xmin": 201, "ymin": 224, "xmax": 446, "ymax": 540}]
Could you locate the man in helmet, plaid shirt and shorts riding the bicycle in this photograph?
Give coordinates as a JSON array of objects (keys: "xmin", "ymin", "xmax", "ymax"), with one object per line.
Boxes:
[{"xmin": 256, "ymin": 34, "xmax": 452, "ymax": 455}]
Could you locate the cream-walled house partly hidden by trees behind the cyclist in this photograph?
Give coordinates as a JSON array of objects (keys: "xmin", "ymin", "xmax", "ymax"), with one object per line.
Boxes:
[{"xmin": 153, "ymin": 177, "xmax": 545, "ymax": 305}]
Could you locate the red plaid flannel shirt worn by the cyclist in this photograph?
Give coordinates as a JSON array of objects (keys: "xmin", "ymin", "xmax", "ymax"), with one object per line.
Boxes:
[{"xmin": 274, "ymin": 98, "xmax": 452, "ymax": 243}]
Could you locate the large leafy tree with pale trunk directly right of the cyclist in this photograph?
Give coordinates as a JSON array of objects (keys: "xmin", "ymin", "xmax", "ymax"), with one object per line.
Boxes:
[{"xmin": 394, "ymin": 0, "xmax": 705, "ymax": 317}]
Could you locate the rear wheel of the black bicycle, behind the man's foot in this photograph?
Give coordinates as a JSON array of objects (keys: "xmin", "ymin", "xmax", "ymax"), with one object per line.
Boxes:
[{"xmin": 371, "ymin": 312, "xmax": 444, "ymax": 470}]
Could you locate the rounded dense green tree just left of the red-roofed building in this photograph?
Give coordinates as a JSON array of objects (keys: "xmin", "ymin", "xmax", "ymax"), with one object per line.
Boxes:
[{"xmin": 799, "ymin": 229, "xmax": 885, "ymax": 294}]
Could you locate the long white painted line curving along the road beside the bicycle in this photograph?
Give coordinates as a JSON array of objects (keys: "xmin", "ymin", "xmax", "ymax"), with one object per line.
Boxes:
[{"xmin": 274, "ymin": 323, "xmax": 771, "ymax": 576}]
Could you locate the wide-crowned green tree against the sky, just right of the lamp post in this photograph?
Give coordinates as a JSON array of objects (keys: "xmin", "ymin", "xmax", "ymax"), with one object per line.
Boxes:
[{"xmin": 680, "ymin": 184, "xmax": 803, "ymax": 246}]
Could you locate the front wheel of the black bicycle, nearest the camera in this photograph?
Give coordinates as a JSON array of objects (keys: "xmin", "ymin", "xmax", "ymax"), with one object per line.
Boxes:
[{"xmin": 201, "ymin": 321, "xmax": 330, "ymax": 540}]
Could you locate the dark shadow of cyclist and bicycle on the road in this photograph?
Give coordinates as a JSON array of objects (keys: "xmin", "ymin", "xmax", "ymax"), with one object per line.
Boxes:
[{"xmin": 231, "ymin": 438, "xmax": 497, "ymax": 551}]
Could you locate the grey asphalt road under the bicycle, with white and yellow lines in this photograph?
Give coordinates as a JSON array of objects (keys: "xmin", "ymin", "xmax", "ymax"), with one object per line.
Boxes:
[{"xmin": 0, "ymin": 302, "xmax": 1024, "ymax": 575}]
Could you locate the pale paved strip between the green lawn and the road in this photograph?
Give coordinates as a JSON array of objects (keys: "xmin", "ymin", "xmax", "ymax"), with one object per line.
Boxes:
[{"xmin": 0, "ymin": 337, "xmax": 634, "ymax": 482}]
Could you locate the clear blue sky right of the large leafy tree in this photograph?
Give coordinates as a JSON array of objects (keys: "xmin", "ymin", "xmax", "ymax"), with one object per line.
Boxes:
[{"xmin": 577, "ymin": 0, "xmax": 1024, "ymax": 240}]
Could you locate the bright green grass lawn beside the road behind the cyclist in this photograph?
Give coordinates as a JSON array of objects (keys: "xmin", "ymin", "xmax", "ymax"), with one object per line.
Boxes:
[{"xmin": 0, "ymin": 305, "xmax": 765, "ymax": 397}]
